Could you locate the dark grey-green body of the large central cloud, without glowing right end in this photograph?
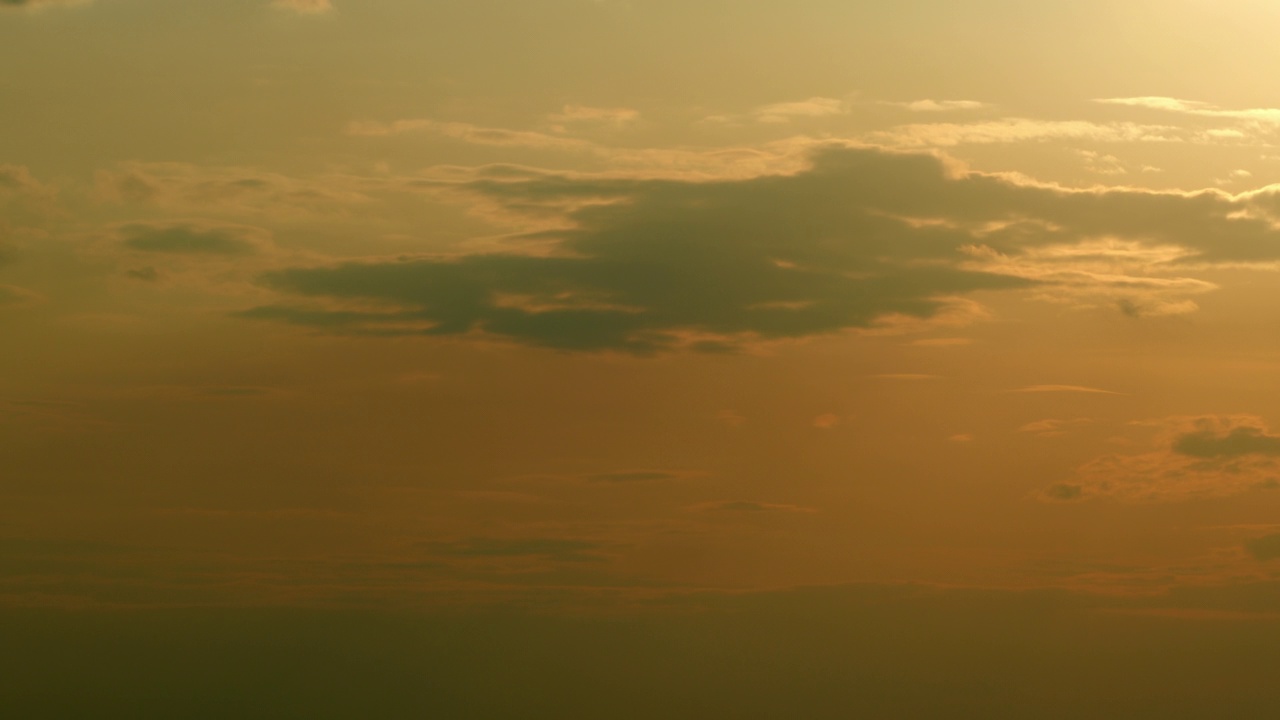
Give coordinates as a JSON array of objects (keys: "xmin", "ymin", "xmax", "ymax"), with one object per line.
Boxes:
[{"xmin": 244, "ymin": 151, "xmax": 1029, "ymax": 354}]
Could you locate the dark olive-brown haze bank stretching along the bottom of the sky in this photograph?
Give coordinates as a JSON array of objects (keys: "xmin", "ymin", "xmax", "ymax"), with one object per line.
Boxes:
[{"xmin": 15, "ymin": 571, "xmax": 1280, "ymax": 720}]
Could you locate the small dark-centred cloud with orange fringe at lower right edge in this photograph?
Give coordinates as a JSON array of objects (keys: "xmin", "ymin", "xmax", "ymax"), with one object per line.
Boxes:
[{"xmin": 1043, "ymin": 415, "xmax": 1280, "ymax": 502}]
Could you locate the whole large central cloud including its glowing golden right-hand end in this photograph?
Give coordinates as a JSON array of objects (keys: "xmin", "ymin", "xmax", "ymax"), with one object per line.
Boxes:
[{"xmin": 244, "ymin": 147, "xmax": 1280, "ymax": 353}]
